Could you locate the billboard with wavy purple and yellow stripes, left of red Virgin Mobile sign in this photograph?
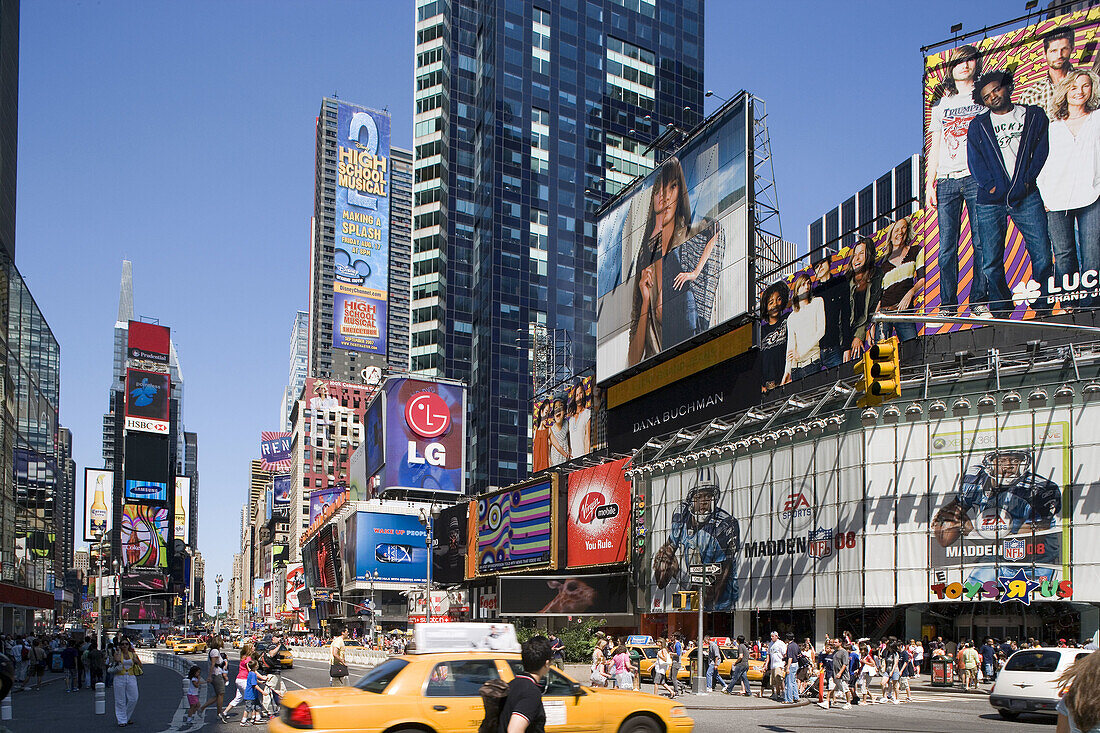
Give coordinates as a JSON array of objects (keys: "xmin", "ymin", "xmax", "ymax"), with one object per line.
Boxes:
[{"xmin": 474, "ymin": 475, "xmax": 558, "ymax": 575}]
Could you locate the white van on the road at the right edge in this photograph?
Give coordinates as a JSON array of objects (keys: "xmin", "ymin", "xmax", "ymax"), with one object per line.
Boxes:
[{"xmin": 989, "ymin": 647, "xmax": 1091, "ymax": 720}]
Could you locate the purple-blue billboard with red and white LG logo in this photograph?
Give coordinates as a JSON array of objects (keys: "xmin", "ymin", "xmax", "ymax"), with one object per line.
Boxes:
[{"xmin": 382, "ymin": 379, "xmax": 466, "ymax": 494}]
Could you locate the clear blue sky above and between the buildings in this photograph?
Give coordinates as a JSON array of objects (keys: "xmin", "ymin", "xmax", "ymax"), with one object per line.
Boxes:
[{"xmin": 17, "ymin": 0, "xmax": 1023, "ymax": 609}]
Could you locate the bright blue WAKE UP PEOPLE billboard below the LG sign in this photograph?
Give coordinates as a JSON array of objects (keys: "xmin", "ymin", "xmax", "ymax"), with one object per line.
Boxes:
[{"xmin": 343, "ymin": 512, "xmax": 426, "ymax": 583}]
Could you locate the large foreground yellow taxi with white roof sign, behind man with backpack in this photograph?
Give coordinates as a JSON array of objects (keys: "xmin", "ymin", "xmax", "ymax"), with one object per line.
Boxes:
[{"xmin": 268, "ymin": 623, "xmax": 694, "ymax": 733}]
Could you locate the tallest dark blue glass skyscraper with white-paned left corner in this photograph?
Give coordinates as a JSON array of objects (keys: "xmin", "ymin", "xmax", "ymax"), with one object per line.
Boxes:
[{"xmin": 409, "ymin": 0, "xmax": 704, "ymax": 490}]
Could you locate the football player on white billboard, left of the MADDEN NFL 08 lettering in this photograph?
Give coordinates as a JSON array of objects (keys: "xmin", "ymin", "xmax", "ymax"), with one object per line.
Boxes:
[{"xmin": 653, "ymin": 467, "xmax": 741, "ymax": 611}]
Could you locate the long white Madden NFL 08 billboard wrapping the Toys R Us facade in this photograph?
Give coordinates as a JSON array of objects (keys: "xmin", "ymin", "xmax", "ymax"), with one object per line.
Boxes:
[{"xmin": 642, "ymin": 406, "xmax": 1086, "ymax": 613}]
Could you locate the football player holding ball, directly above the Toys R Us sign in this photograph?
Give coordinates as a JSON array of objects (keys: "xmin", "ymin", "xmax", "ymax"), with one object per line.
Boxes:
[{"xmin": 932, "ymin": 449, "xmax": 1062, "ymax": 547}]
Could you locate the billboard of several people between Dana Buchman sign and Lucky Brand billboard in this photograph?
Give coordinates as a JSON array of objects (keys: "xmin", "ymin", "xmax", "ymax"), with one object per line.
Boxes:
[{"xmin": 758, "ymin": 210, "xmax": 927, "ymax": 393}]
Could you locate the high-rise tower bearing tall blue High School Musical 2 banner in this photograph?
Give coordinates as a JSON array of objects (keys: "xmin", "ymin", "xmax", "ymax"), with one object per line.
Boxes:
[{"xmin": 308, "ymin": 97, "xmax": 413, "ymax": 383}]
